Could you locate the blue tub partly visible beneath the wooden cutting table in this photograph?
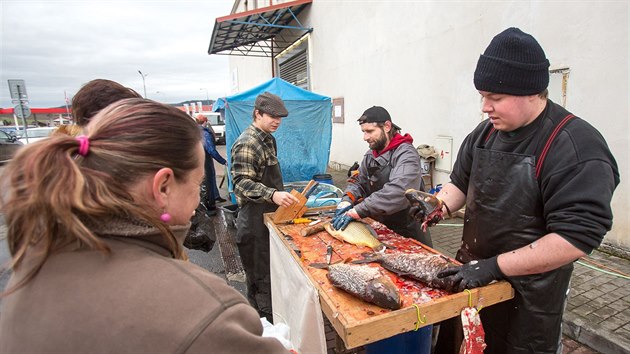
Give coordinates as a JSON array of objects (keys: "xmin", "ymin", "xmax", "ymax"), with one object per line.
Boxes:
[{"xmin": 365, "ymin": 325, "xmax": 433, "ymax": 354}]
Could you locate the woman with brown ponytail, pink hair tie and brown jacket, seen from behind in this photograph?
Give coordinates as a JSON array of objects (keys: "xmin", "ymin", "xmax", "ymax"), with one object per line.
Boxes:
[{"xmin": 0, "ymin": 99, "xmax": 284, "ymax": 353}]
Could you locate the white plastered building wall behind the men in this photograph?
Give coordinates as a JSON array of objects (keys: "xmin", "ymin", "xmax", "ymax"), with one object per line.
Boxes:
[{"xmin": 231, "ymin": 0, "xmax": 630, "ymax": 249}]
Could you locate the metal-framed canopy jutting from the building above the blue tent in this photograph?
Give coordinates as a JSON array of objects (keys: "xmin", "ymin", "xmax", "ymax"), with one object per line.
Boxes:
[{"xmin": 208, "ymin": 0, "xmax": 313, "ymax": 58}]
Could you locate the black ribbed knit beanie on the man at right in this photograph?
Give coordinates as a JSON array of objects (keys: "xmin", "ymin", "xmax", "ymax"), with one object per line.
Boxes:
[{"xmin": 474, "ymin": 27, "xmax": 549, "ymax": 96}]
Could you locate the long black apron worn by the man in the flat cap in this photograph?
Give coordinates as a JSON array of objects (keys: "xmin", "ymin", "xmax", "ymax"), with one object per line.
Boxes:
[{"xmin": 236, "ymin": 142, "xmax": 283, "ymax": 323}]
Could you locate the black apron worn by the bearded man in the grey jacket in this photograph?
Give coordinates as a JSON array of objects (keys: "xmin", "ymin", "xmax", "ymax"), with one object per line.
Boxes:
[{"xmin": 367, "ymin": 156, "xmax": 433, "ymax": 247}]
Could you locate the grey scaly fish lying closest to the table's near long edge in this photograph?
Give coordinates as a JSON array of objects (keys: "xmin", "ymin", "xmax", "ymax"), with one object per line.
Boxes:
[{"xmin": 311, "ymin": 263, "xmax": 402, "ymax": 310}]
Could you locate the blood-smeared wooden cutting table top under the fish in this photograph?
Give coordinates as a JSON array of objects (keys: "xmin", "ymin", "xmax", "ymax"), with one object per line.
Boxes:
[{"xmin": 265, "ymin": 214, "xmax": 514, "ymax": 349}]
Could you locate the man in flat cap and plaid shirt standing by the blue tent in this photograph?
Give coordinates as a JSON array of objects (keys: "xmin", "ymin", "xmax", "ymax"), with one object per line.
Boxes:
[{"xmin": 230, "ymin": 92, "xmax": 298, "ymax": 323}]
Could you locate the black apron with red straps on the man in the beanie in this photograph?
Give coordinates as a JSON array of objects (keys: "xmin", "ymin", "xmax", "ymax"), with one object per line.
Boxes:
[{"xmin": 456, "ymin": 115, "xmax": 573, "ymax": 354}]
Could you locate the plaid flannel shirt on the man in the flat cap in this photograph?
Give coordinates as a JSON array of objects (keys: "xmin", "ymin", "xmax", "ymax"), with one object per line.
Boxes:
[{"xmin": 230, "ymin": 124, "xmax": 278, "ymax": 206}]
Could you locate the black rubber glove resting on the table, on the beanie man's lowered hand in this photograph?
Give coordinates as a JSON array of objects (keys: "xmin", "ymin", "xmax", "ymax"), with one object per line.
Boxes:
[{"xmin": 437, "ymin": 256, "xmax": 505, "ymax": 292}]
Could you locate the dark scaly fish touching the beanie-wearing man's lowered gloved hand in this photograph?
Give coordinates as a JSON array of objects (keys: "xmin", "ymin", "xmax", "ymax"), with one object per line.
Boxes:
[{"xmin": 350, "ymin": 251, "xmax": 450, "ymax": 289}]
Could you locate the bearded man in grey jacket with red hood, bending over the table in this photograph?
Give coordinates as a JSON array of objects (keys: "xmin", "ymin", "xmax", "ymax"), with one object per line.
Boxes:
[{"xmin": 332, "ymin": 106, "xmax": 432, "ymax": 246}]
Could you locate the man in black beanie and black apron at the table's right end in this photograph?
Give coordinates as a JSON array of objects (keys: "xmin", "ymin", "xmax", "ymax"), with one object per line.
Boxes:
[{"xmin": 411, "ymin": 28, "xmax": 619, "ymax": 353}]
